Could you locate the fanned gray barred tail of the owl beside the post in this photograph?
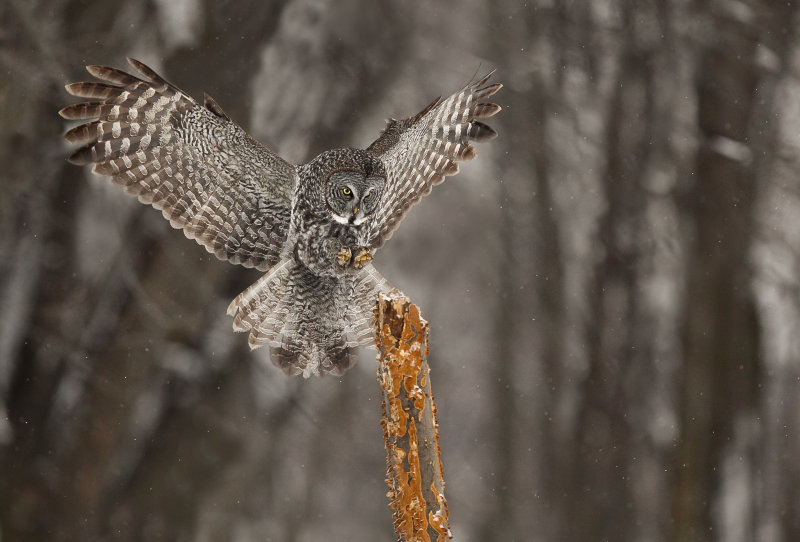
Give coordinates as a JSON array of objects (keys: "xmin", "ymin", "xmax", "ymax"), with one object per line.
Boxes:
[{"xmin": 228, "ymin": 259, "xmax": 391, "ymax": 378}]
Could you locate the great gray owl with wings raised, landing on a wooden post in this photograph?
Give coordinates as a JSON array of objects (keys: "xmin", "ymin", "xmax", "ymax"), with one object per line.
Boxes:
[{"xmin": 60, "ymin": 58, "xmax": 502, "ymax": 377}]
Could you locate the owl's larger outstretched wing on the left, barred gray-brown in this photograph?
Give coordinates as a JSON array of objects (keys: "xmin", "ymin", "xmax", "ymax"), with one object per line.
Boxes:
[{"xmin": 59, "ymin": 58, "xmax": 297, "ymax": 270}]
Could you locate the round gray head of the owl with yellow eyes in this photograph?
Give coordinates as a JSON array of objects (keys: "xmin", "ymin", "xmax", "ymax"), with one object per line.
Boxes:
[{"xmin": 312, "ymin": 149, "xmax": 386, "ymax": 226}]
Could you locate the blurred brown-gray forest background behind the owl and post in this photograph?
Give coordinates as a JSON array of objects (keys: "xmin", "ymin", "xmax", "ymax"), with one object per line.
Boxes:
[{"xmin": 0, "ymin": 0, "xmax": 800, "ymax": 542}]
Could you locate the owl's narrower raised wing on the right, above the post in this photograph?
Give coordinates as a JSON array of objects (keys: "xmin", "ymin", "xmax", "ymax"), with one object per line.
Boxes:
[{"xmin": 367, "ymin": 72, "xmax": 503, "ymax": 248}]
